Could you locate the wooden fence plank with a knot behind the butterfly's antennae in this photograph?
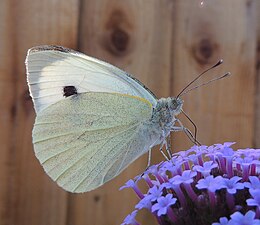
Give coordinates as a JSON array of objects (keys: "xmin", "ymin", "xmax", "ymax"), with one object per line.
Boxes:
[{"xmin": 172, "ymin": 0, "xmax": 256, "ymax": 151}]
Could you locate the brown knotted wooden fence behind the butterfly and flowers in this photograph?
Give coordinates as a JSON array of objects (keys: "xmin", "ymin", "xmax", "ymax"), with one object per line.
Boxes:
[{"xmin": 0, "ymin": 0, "xmax": 260, "ymax": 225}]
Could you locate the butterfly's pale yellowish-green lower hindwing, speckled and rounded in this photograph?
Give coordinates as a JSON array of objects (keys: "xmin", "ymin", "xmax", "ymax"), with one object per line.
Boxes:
[{"xmin": 33, "ymin": 92, "xmax": 152, "ymax": 192}]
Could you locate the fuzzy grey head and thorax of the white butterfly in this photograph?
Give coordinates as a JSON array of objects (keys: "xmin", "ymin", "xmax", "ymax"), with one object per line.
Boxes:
[{"xmin": 151, "ymin": 97, "xmax": 183, "ymax": 136}]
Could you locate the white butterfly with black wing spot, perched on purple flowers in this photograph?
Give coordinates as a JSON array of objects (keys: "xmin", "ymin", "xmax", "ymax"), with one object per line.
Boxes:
[{"xmin": 26, "ymin": 46, "xmax": 217, "ymax": 193}]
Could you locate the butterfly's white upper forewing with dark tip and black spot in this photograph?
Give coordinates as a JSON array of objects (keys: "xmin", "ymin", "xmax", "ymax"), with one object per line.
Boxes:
[{"xmin": 26, "ymin": 45, "xmax": 156, "ymax": 112}]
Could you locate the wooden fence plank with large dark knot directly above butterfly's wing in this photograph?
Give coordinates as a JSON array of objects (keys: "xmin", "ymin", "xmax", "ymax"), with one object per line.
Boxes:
[{"xmin": 68, "ymin": 0, "xmax": 173, "ymax": 225}]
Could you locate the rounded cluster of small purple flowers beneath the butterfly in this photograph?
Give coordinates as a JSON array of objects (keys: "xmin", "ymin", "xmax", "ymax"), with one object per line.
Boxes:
[{"xmin": 121, "ymin": 142, "xmax": 260, "ymax": 225}]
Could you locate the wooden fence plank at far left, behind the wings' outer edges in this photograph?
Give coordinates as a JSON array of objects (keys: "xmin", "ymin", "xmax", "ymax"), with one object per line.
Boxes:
[{"xmin": 0, "ymin": 0, "xmax": 79, "ymax": 225}]
